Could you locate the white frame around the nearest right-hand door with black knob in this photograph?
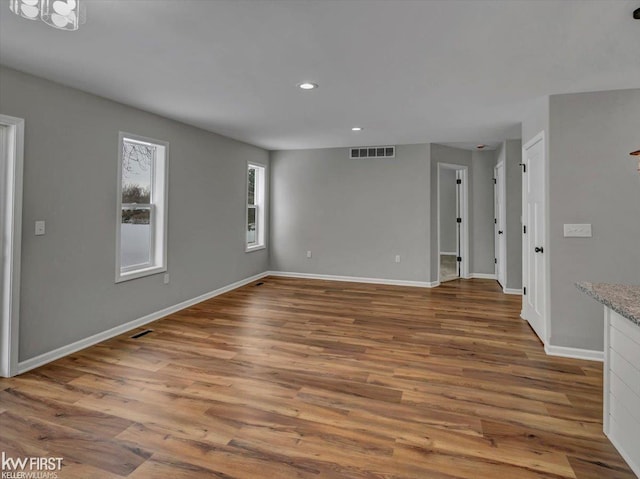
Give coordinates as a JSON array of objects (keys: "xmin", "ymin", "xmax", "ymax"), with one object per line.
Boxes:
[{"xmin": 520, "ymin": 130, "xmax": 551, "ymax": 348}]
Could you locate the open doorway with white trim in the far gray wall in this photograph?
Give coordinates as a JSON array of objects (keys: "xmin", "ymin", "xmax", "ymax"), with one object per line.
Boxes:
[{"xmin": 437, "ymin": 163, "xmax": 469, "ymax": 283}]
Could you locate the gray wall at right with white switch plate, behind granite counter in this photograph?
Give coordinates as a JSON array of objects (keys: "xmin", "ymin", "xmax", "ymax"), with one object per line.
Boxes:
[{"xmin": 548, "ymin": 89, "xmax": 640, "ymax": 350}]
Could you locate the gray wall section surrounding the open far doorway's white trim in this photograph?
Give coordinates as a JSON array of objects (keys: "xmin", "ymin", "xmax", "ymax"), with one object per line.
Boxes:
[{"xmin": 430, "ymin": 143, "xmax": 473, "ymax": 282}]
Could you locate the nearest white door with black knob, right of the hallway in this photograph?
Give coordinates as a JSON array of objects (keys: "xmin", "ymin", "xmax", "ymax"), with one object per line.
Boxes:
[{"xmin": 522, "ymin": 135, "xmax": 547, "ymax": 344}]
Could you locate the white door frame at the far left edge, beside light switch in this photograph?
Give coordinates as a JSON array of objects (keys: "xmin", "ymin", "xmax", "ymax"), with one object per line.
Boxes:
[{"xmin": 0, "ymin": 114, "xmax": 24, "ymax": 377}]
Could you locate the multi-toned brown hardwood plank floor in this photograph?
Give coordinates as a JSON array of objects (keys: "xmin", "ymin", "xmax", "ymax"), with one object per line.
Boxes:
[{"xmin": 0, "ymin": 277, "xmax": 635, "ymax": 479}]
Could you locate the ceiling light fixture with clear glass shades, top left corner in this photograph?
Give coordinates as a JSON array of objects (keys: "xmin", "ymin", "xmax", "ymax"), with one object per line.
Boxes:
[{"xmin": 9, "ymin": 0, "xmax": 86, "ymax": 31}]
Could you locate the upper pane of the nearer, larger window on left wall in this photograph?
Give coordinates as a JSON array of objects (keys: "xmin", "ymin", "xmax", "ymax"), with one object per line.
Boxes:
[{"xmin": 122, "ymin": 140, "xmax": 156, "ymax": 204}]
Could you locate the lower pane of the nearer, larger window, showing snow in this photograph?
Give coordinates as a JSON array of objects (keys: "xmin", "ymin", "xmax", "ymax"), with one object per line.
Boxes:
[{"xmin": 120, "ymin": 206, "xmax": 152, "ymax": 269}]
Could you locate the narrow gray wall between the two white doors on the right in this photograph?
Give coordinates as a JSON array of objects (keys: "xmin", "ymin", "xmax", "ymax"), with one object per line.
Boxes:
[{"xmin": 496, "ymin": 139, "xmax": 524, "ymax": 290}]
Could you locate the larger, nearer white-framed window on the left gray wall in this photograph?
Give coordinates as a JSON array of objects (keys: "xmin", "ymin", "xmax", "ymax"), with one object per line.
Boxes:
[{"xmin": 116, "ymin": 133, "xmax": 169, "ymax": 282}]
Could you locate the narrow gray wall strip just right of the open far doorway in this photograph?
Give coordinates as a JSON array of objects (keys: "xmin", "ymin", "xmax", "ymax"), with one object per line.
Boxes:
[{"xmin": 471, "ymin": 151, "xmax": 496, "ymax": 274}]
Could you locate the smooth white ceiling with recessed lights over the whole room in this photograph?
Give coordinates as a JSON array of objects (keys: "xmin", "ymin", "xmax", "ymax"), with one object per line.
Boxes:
[{"xmin": 0, "ymin": 0, "xmax": 640, "ymax": 149}]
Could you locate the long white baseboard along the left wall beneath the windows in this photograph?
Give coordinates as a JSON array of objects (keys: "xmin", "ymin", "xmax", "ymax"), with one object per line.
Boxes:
[{"xmin": 18, "ymin": 273, "xmax": 267, "ymax": 374}]
